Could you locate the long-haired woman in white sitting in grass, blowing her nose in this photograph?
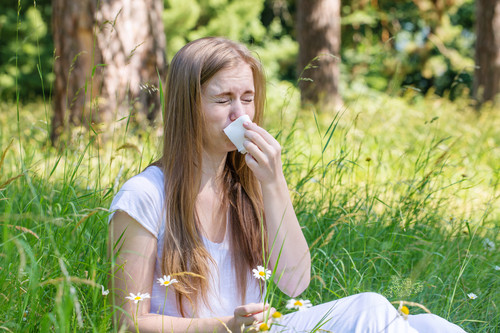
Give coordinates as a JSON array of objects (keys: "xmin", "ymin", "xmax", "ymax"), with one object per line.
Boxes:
[{"xmin": 109, "ymin": 38, "xmax": 463, "ymax": 332}]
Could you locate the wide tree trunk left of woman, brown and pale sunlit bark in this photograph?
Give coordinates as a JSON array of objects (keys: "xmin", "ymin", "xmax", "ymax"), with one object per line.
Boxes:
[{"xmin": 51, "ymin": 0, "xmax": 166, "ymax": 142}]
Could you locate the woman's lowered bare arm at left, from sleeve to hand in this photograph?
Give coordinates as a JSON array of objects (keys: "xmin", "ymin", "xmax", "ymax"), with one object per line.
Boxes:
[{"xmin": 108, "ymin": 211, "xmax": 270, "ymax": 333}]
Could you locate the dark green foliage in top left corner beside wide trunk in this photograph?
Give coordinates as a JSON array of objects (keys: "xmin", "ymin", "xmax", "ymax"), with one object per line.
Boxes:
[{"xmin": 0, "ymin": 0, "xmax": 54, "ymax": 99}]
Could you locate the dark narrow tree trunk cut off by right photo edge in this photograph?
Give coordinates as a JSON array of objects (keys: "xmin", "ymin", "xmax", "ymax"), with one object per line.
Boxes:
[{"xmin": 473, "ymin": 0, "xmax": 500, "ymax": 104}]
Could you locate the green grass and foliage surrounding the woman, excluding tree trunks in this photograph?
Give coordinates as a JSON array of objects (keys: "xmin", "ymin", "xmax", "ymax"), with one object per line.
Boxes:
[{"xmin": 0, "ymin": 0, "xmax": 500, "ymax": 332}]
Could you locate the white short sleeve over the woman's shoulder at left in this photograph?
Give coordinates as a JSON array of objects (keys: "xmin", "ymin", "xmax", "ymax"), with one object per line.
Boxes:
[{"xmin": 109, "ymin": 166, "xmax": 165, "ymax": 237}]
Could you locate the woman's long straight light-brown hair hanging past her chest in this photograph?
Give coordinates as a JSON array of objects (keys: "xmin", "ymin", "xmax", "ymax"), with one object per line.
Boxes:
[{"xmin": 158, "ymin": 37, "xmax": 267, "ymax": 316}]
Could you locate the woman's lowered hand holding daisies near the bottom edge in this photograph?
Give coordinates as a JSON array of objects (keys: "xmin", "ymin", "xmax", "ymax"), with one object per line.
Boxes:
[{"xmin": 228, "ymin": 303, "xmax": 276, "ymax": 333}]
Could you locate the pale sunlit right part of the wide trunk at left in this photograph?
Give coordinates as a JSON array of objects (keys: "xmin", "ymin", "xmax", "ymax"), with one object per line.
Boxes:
[{"xmin": 97, "ymin": 0, "xmax": 166, "ymax": 124}]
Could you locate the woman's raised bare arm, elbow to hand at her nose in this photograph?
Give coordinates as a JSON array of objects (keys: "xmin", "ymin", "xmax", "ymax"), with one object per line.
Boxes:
[{"xmin": 244, "ymin": 123, "xmax": 311, "ymax": 297}]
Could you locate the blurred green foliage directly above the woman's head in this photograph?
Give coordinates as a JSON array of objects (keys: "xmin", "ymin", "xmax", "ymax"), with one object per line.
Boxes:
[{"xmin": 163, "ymin": 0, "xmax": 298, "ymax": 87}]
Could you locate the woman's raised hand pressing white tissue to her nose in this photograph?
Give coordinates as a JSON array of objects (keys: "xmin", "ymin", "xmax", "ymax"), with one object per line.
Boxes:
[{"xmin": 243, "ymin": 122, "xmax": 284, "ymax": 184}]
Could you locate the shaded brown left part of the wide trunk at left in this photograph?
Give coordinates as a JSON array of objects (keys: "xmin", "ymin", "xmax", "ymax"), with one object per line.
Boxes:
[{"xmin": 51, "ymin": 0, "xmax": 100, "ymax": 143}]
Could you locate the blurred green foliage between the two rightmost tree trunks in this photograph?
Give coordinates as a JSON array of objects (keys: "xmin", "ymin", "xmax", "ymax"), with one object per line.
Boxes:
[{"xmin": 342, "ymin": 0, "xmax": 475, "ymax": 99}]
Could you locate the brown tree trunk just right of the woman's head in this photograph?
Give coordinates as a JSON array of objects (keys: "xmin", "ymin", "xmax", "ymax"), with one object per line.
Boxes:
[{"xmin": 297, "ymin": 0, "xmax": 341, "ymax": 107}]
